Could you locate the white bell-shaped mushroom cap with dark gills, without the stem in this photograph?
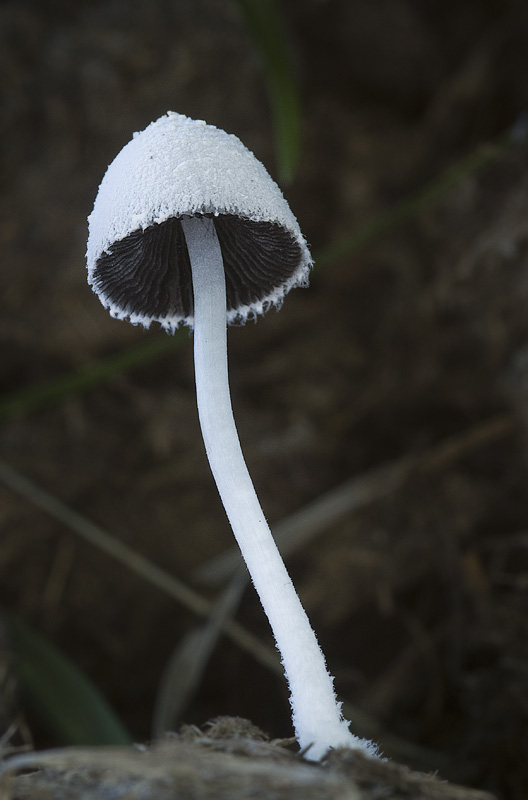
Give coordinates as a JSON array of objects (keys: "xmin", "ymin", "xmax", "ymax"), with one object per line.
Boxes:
[{"xmin": 87, "ymin": 111, "xmax": 312, "ymax": 330}]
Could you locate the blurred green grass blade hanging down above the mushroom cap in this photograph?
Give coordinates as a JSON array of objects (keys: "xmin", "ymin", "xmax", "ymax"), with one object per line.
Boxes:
[{"xmin": 234, "ymin": 0, "xmax": 301, "ymax": 184}]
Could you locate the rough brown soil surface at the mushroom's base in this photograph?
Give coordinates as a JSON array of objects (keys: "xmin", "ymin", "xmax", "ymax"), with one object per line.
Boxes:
[{"xmin": 0, "ymin": 717, "xmax": 493, "ymax": 800}]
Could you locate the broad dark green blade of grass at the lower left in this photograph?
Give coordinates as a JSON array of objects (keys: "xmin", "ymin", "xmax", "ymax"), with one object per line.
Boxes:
[{"xmin": 6, "ymin": 614, "xmax": 132, "ymax": 745}]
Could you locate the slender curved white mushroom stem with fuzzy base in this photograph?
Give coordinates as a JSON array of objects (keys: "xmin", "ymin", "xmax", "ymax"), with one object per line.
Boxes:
[{"xmin": 182, "ymin": 217, "xmax": 368, "ymax": 760}]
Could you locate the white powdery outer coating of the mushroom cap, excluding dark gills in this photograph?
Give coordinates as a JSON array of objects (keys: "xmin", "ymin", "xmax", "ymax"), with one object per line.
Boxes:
[{"xmin": 86, "ymin": 111, "xmax": 312, "ymax": 330}]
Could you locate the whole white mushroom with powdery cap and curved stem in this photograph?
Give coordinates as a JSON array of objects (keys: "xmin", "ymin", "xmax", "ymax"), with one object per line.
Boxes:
[{"xmin": 87, "ymin": 112, "xmax": 376, "ymax": 760}]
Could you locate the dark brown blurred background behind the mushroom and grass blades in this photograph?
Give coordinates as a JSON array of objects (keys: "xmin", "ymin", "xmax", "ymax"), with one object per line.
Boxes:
[{"xmin": 0, "ymin": 0, "xmax": 528, "ymax": 798}]
